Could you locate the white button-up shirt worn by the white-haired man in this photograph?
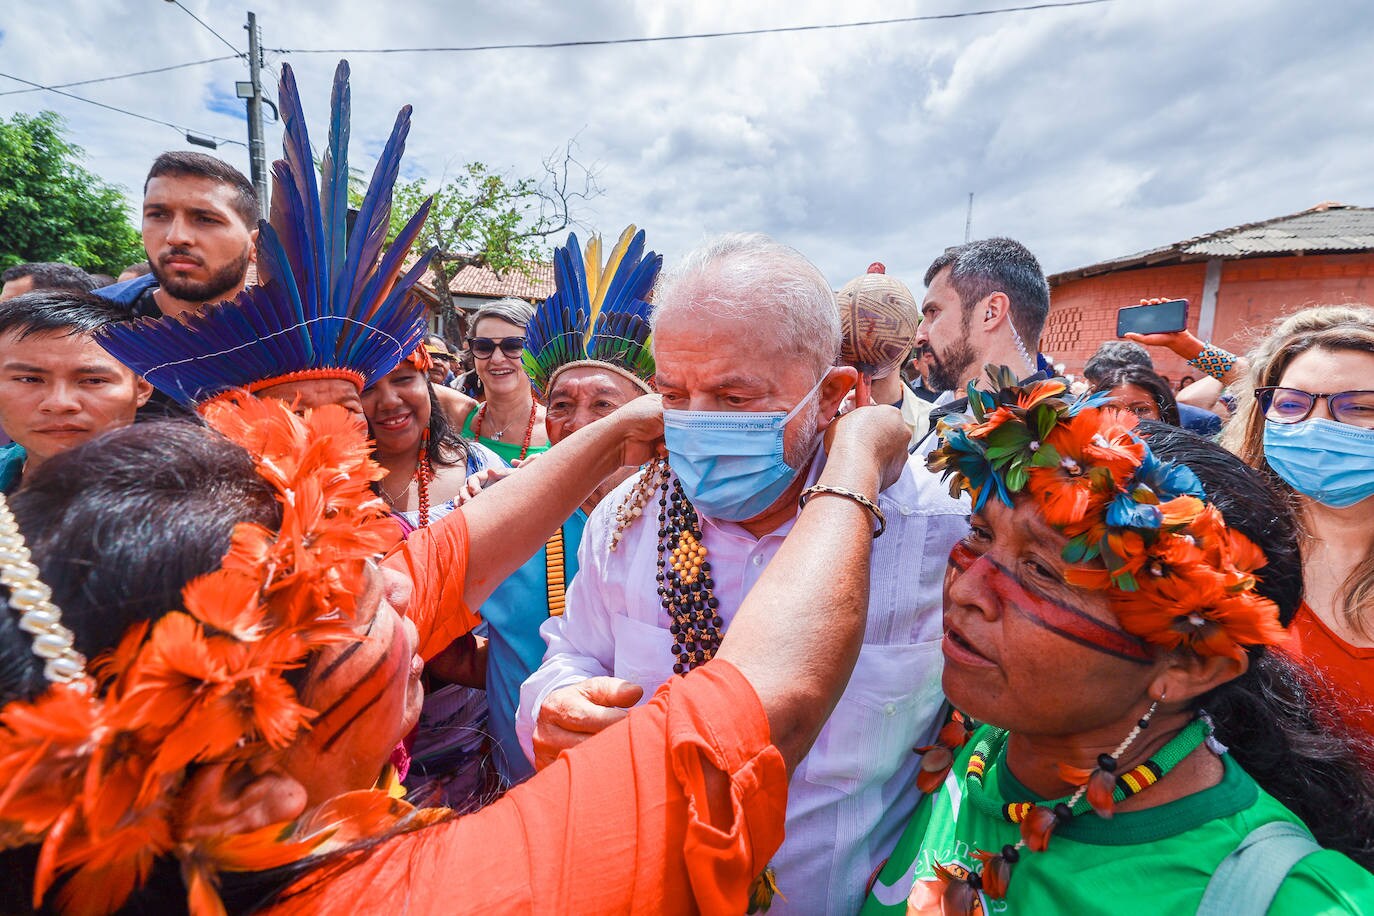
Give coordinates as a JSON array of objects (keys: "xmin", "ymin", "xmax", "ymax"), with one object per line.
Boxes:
[{"xmin": 515, "ymin": 455, "xmax": 969, "ymax": 913}]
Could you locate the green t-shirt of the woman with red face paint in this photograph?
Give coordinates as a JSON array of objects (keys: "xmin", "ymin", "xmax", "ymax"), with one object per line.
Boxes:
[{"xmin": 861, "ymin": 726, "xmax": 1374, "ymax": 916}]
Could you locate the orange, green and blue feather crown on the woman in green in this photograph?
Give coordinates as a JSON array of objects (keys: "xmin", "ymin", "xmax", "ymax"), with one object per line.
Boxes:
[{"xmin": 929, "ymin": 365, "xmax": 1283, "ymax": 658}]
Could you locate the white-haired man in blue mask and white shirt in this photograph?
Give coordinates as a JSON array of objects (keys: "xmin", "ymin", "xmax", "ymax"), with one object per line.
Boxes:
[{"xmin": 517, "ymin": 235, "xmax": 967, "ymax": 913}]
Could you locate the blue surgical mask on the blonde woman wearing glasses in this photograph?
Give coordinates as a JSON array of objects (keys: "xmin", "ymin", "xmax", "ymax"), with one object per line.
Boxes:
[{"xmin": 1264, "ymin": 416, "xmax": 1374, "ymax": 509}]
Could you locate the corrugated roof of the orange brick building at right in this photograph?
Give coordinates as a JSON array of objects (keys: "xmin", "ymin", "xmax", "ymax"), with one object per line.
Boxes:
[{"xmin": 1050, "ymin": 203, "xmax": 1374, "ymax": 286}]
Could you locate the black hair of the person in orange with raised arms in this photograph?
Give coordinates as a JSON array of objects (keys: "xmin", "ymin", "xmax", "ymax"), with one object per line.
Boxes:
[{"xmin": 0, "ymin": 420, "xmax": 280, "ymax": 703}]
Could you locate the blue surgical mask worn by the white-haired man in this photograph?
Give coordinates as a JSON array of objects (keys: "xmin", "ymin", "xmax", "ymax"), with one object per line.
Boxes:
[{"xmin": 664, "ymin": 375, "xmax": 826, "ymax": 522}]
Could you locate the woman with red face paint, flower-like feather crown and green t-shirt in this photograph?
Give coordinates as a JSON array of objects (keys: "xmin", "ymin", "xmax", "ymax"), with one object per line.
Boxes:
[{"xmin": 863, "ymin": 375, "xmax": 1374, "ymax": 916}]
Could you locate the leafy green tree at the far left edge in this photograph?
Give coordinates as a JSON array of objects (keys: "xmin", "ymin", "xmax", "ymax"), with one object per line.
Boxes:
[{"xmin": 0, "ymin": 111, "xmax": 146, "ymax": 276}]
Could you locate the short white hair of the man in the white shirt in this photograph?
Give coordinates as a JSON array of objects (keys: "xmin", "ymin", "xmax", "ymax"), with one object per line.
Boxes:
[{"xmin": 651, "ymin": 232, "xmax": 840, "ymax": 378}]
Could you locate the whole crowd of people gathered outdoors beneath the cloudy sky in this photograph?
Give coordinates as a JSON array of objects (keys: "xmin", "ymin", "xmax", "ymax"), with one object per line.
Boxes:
[{"xmin": 0, "ymin": 63, "xmax": 1374, "ymax": 915}]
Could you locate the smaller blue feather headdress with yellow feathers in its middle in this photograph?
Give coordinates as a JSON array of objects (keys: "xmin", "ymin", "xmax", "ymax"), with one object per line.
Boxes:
[{"xmin": 523, "ymin": 225, "xmax": 664, "ymax": 398}]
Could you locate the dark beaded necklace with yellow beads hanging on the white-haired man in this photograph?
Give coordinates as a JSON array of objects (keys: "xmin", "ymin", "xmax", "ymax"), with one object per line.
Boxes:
[{"xmin": 654, "ymin": 477, "xmax": 725, "ymax": 674}]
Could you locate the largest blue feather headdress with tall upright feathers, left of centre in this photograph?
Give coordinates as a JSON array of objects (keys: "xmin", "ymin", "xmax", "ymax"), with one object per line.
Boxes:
[{"xmin": 100, "ymin": 60, "xmax": 433, "ymax": 407}]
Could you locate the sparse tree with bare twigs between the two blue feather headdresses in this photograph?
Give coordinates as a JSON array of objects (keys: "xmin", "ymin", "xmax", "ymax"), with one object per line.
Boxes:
[{"xmin": 390, "ymin": 141, "xmax": 600, "ymax": 324}]
